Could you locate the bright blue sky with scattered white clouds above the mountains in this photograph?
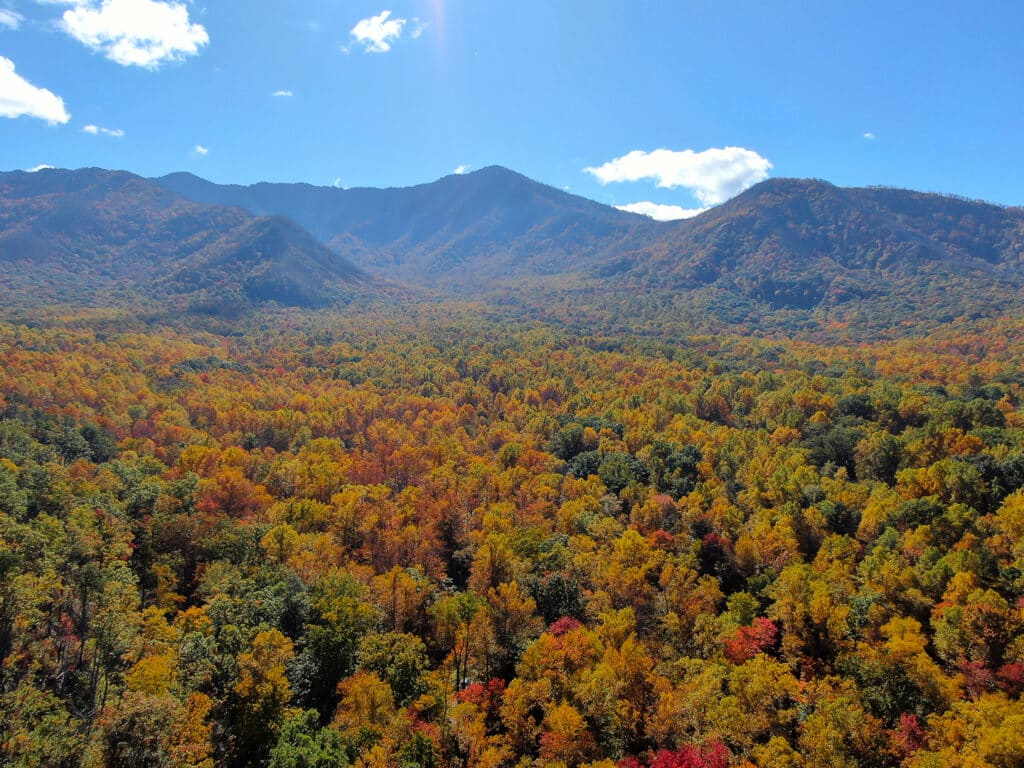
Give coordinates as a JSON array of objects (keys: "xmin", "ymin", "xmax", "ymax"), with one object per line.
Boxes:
[{"xmin": 0, "ymin": 0, "xmax": 1024, "ymax": 215}]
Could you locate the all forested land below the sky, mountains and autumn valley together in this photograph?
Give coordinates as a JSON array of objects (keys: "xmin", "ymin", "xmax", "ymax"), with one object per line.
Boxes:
[{"xmin": 0, "ymin": 163, "xmax": 1024, "ymax": 768}]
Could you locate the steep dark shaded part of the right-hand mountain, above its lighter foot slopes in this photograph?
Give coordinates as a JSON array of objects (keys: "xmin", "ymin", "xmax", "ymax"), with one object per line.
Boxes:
[{"xmin": 626, "ymin": 179, "xmax": 1024, "ymax": 309}]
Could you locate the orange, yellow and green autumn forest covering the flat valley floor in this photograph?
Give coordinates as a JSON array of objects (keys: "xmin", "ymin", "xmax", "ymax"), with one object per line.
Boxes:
[{"xmin": 0, "ymin": 301, "xmax": 1024, "ymax": 768}]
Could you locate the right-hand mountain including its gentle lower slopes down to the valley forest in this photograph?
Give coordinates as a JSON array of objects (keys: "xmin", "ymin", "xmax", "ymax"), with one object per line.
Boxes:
[{"xmin": 552, "ymin": 179, "xmax": 1024, "ymax": 339}]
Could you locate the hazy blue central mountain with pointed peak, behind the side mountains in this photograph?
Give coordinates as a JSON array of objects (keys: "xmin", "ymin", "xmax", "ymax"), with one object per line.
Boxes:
[{"xmin": 156, "ymin": 166, "xmax": 655, "ymax": 291}]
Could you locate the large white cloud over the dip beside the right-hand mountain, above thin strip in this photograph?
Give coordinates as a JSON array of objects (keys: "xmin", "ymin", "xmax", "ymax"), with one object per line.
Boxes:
[{"xmin": 584, "ymin": 146, "xmax": 772, "ymax": 206}]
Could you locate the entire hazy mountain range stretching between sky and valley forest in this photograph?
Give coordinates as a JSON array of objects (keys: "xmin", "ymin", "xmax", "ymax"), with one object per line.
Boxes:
[{"xmin": 0, "ymin": 162, "xmax": 1024, "ymax": 326}]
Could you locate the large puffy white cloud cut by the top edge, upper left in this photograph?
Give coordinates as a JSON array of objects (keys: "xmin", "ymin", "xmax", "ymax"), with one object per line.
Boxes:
[{"xmin": 61, "ymin": 0, "xmax": 210, "ymax": 70}]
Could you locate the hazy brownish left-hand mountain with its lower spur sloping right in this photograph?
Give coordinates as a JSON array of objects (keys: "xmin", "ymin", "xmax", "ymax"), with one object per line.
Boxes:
[{"xmin": 0, "ymin": 168, "xmax": 366, "ymax": 312}]
